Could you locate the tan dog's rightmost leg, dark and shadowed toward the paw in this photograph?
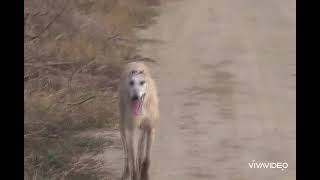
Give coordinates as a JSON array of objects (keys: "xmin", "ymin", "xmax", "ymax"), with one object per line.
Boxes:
[{"xmin": 141, "ymin": 128, "xmax": 155, "ymax": 180}]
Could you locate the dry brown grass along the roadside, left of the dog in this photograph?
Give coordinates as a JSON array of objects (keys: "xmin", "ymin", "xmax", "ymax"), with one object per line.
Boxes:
[{"xmin": 24, "ymin": 0, "xmax": 160, "ymax": 179}]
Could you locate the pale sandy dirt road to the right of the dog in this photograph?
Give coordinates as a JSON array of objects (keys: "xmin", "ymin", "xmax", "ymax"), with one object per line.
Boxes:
[{"xmin": 101, "ymin": 0, "xmax": 296, "ymax": 180}]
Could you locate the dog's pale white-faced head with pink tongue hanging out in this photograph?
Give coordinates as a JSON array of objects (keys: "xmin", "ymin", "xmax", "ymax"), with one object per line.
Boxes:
[{"xmin": 127, "ymin": 70, "xmax": 148, "ymax": 116}]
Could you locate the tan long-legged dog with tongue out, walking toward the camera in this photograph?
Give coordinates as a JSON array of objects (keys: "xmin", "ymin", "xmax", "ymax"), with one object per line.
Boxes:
[{"xmin": 119, "ymin": 62, "xmax": 159, "ymax": 180}]
